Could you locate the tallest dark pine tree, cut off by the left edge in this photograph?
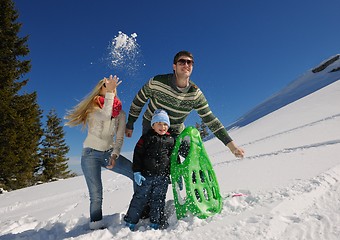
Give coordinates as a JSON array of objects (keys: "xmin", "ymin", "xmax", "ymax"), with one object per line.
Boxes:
[{"xmin": 0, "ymin": 0, "xmax": 42, "ymax": 190}]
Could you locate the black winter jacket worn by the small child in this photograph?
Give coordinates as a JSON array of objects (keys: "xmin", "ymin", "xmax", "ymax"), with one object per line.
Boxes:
[{"xmin": 132, "ymin": 129, "xmax": 175, "ymax": 177}]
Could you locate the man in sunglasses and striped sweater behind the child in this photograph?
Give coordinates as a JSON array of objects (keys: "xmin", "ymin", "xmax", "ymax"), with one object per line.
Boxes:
[{"xmin": 125, "ymin": 51, "xmax": 244, "ymax": 158}]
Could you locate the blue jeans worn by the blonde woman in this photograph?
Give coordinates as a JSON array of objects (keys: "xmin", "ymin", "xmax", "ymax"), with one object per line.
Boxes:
[{"xmin": 81, "ymin": 148, "xmax": 133, "ymax": 222}]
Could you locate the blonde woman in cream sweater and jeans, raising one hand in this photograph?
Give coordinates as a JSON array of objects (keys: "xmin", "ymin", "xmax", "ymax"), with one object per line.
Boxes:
[{"xmin": 65, "ymin": 75, "xmax": 134, "ymax": 230}]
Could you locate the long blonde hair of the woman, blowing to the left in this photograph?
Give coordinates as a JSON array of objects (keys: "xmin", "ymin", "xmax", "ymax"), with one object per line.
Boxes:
[{"xmin": 65, "ymin": 79, "xmax": 115, "ymax": 129}]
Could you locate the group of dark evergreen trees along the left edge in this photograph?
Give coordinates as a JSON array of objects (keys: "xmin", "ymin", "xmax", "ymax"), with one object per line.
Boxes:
[{"xmin": 0, "ymin": 0, "xmax": 76, "ymax": 190}]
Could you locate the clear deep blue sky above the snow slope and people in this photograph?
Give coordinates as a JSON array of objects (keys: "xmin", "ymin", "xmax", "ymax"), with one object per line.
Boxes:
[{"xmin": 14, "ymin": 0, "xmax": 340, "ymax": 170}]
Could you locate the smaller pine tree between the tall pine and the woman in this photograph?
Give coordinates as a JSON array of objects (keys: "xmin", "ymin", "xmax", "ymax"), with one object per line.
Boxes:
[{"xmin": 40, "ymin": 109, "xmax": 75, "ymax": 182}]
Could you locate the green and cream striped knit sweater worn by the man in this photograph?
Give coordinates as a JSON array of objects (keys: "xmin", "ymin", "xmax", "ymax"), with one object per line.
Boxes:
[{"xmin": 126, "ymin": 74, "xmax": 232, "ymax": 144}]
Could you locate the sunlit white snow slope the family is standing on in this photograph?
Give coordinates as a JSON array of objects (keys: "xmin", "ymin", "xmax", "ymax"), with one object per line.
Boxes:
[{"xmin": 0, "ymin": 78, "xmax": 340, "ymax": 240}]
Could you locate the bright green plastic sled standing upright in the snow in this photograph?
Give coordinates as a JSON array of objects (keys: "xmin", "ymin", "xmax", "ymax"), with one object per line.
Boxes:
[{"xmin": 171, "ymin": 127, "xmax": 223, "ymax": 219}]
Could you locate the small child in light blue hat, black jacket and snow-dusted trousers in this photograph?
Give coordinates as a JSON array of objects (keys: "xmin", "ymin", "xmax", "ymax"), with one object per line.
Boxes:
[{"xmin": 124, "ymin": 109, "xmax": 175, "ymax": 230}]
